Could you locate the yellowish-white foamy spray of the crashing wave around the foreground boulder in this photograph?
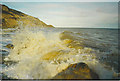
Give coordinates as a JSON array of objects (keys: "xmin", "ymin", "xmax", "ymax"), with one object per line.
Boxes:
[{"xmin": 3, "ymin": 28, "xmax": 117, "ymax": 79}]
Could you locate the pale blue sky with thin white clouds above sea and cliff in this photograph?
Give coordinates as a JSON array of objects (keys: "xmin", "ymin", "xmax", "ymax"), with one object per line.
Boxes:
[{"xmin": 2, "ymin": 0, "xmax": 118, "ymax": 28}]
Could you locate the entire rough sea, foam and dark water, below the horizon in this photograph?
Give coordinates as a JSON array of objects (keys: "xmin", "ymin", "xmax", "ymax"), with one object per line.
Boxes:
[{"xmin": 0, "ymin": 28, "xmax": 120, "ymax": 79}]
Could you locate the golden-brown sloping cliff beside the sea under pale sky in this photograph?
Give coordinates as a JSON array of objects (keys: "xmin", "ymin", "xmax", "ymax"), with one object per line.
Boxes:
[{"xmin": 0, "ymin": 5, "xmax": 53, "ymax": 28}]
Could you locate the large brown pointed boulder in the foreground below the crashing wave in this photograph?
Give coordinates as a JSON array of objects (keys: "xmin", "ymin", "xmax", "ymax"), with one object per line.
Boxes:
[{"xmin": 53, "ymin": 63, "xmax": 99, "ymax": 80}]
